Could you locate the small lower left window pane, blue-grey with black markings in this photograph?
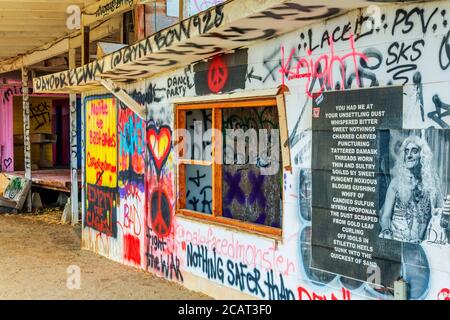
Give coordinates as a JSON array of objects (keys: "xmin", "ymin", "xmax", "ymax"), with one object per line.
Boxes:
[{"xmin": 186, "ymin": 165, "xmax": 212, "ymax": 214}]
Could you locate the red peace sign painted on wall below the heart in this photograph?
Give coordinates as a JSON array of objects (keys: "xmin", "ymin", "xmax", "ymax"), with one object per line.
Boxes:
[{"xmin": 150, "ymin": 189, "xmax": 172, "ymax": 237}]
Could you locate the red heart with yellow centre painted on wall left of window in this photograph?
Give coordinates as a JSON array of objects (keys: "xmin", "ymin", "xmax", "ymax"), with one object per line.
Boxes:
[{"xmin": 147, "ymin": 125, "xmax": 172, "ymax": 175}]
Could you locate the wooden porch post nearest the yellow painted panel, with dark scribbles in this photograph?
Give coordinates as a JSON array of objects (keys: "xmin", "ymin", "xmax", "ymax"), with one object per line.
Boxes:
[{"xmin": 69, "ymin": 48, "xmax": 78, "ymax": 225}]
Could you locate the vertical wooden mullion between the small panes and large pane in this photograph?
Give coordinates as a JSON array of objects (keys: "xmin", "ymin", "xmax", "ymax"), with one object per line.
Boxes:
[{"xmin": 211, "ymin": 109, "xmax": 223, "ymax": 216}]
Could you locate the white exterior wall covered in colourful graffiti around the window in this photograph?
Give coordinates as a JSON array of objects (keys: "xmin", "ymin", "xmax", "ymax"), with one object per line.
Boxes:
[{"xmin": 83, "ymin": 1, "xmax": 450, "ymax": 300}]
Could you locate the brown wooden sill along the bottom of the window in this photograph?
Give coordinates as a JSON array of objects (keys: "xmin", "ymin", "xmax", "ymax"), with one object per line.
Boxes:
[{"xmin": 177, "ymin": 209, "xmax": 283, "ymax": 239}]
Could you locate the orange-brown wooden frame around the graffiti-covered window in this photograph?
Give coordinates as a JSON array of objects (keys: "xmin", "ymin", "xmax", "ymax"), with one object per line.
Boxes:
[{"xmin": 174, "ymin": 96, "xmax": 290, "ymax": 240}]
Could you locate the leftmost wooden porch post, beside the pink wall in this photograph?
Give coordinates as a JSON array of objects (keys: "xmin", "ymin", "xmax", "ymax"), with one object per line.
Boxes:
[{"xmin": 22, "ymin": 65, "xmax": 32, "ymax": 212}]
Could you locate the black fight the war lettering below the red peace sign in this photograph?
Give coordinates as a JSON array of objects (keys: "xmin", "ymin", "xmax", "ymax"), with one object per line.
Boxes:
[{"xmin": 147, "ymin": 228, "xmax": 183, "ymax": 282}]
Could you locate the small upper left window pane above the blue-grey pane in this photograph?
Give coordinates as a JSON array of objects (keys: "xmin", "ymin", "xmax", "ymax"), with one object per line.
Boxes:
[{"xmin": 186, "ymin": 109, "xmax": 212, "ymax": 161}]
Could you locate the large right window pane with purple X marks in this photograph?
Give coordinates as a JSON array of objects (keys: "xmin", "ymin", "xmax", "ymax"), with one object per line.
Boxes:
[{"xmin": 222, "ymin": 107, "xmax": 282, "ymax": 228}]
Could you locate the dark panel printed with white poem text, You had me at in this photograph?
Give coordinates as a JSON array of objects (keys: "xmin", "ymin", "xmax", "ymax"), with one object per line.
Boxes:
[{"xmin": 311, "ymin": 87, "xmax": 403, "ymax": 288}]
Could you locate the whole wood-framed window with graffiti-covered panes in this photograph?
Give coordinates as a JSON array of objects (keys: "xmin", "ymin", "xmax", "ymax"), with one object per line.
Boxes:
[{"xmin": 174, "ymin": 98, "xmax": 284, "ymax": 236}]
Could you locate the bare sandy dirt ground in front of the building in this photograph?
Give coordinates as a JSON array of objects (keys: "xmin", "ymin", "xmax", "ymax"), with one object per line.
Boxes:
[{"xmin": 0, "ymin": 213, "xmax": 209, "ymax": 300}]
